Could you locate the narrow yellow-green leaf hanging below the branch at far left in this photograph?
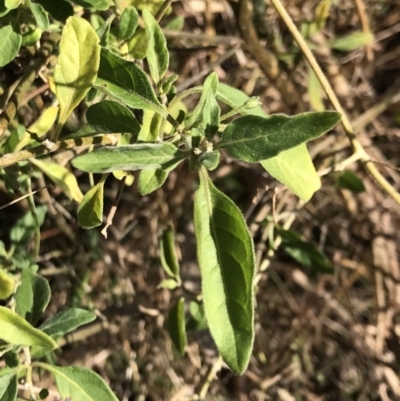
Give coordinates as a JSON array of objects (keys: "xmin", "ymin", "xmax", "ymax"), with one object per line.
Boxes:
[{"xmin": 31, "ymin": 159, "xmax": 83, "ymax": 203}]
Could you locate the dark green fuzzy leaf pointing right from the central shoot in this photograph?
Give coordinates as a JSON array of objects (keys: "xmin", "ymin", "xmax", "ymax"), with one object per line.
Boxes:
[{"xmin": 218, "ymin": 111, "xmax": 340, "ymax": 163}]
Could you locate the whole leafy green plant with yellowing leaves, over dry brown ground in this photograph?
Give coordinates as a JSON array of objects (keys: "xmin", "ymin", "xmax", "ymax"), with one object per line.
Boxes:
[{"xmin": 0, "ymin": 0, "xmax": 340, "ymax": 401}]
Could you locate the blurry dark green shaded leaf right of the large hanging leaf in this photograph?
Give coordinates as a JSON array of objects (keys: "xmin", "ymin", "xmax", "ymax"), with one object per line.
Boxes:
[{"xmin": 276, "ymin": 227, "xmax": 333, "ymax": 274}]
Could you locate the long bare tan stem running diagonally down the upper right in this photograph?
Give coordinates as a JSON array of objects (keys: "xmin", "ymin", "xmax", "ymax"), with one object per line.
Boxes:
[{"xmin": 271, "ymin": 0, "xmax": 400, "ymax": 205}]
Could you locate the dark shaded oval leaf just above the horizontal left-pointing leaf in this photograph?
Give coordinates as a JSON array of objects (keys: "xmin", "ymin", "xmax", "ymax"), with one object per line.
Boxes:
[{"xmin": 86, "ymin": 100, "xmax": 140, "ymax": 136}]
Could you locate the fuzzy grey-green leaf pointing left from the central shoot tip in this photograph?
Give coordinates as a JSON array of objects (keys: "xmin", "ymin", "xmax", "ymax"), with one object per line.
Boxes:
[{"xmin": 72, "ymin": 142, "xmax": 188, "ymax": 173}]
